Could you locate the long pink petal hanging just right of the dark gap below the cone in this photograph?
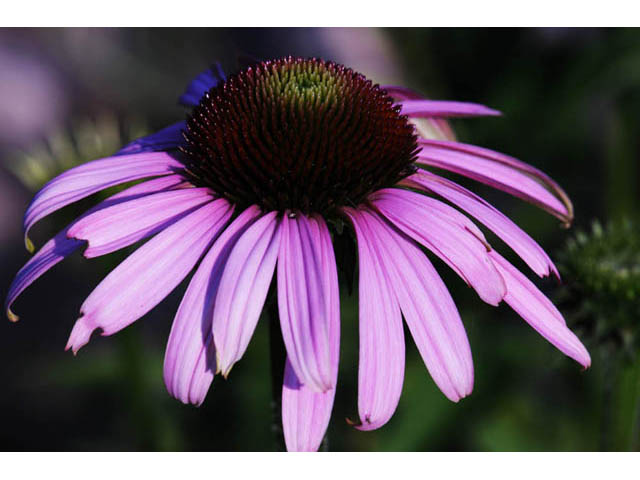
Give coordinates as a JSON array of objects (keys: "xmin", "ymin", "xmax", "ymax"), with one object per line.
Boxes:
[{"xmin": 353, "ymin": 208, "xmax": 405, "ymax": 430}]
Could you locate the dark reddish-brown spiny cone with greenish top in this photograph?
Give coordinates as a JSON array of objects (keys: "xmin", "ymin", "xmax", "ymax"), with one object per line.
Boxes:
[{"xmin": 183, "ymin": 57, "xmax": 417, "ymax": 215}]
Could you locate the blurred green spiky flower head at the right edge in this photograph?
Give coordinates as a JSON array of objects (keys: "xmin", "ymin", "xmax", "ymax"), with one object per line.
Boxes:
[{"xmin": 557, "ymin": 219, "xmax": 640, "ymax": 362}]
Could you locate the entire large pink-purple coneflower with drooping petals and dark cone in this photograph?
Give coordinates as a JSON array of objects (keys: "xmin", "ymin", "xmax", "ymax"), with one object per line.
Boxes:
[{"xmin": 6, "ymin": 58, "xmax": 590, "ymax": 450}]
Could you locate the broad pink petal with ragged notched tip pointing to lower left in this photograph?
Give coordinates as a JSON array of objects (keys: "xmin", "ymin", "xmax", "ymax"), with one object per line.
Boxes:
[{"xmin": 67, "ymin": 199, "xmax": 233, "ymax": 353}]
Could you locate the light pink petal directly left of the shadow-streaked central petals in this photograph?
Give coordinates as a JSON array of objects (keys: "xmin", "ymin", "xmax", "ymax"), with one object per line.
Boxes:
[{"xmin": 211, "ymin": 212, "xmax": 280, "ymax": 377}]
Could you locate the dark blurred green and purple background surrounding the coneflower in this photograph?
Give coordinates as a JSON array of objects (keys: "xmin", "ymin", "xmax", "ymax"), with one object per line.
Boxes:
[{"xmin": 0, "ymin": 29, "xmax": 640, "ymax": 451}]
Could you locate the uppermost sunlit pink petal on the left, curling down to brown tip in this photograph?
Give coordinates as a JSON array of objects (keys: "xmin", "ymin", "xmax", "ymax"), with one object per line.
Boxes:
[{"xmin": 24, "ymin": 152, "xmax": 182, "ymax": 251}]
